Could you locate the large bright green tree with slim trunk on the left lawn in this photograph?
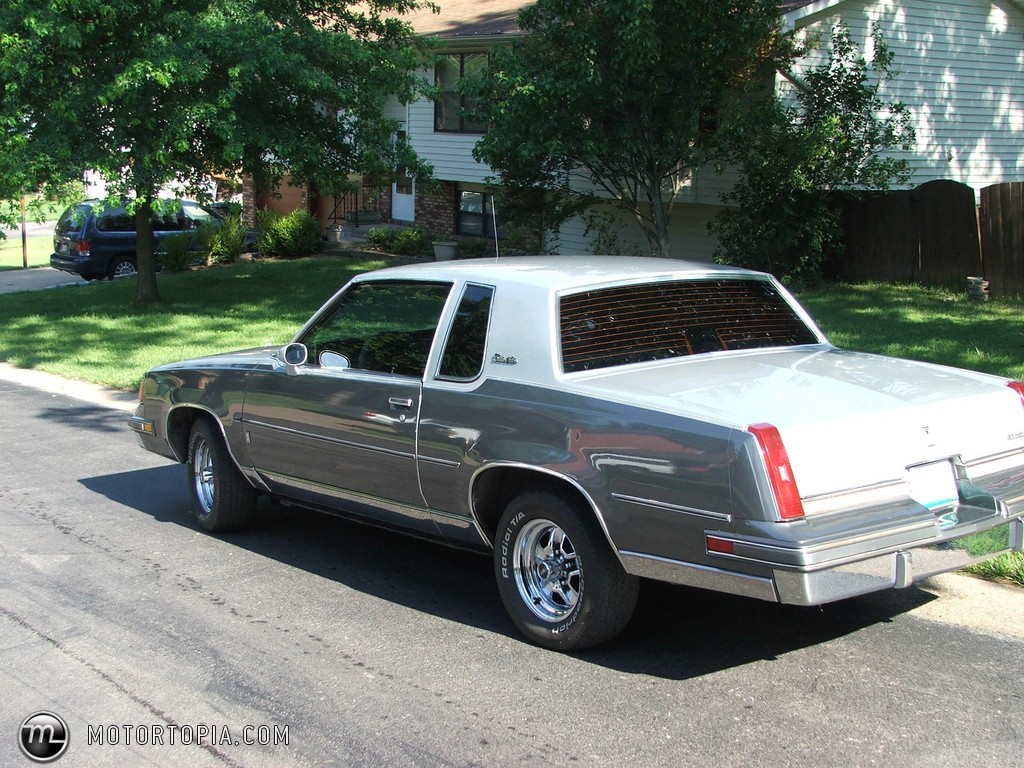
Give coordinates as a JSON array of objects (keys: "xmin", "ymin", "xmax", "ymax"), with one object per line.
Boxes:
[{"xmin": 0, "ymin": 0, "xmax": 426, "ymax": 303}]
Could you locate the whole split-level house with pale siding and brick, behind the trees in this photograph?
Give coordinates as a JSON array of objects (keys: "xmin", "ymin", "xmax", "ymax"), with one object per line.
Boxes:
[{"xmin": 258, "ymin": 0, "xmax": 1024, "ymax": 259}]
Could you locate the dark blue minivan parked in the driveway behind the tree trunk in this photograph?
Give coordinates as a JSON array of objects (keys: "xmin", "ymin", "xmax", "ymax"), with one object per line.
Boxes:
[{"xmin": 50, "ymin": 200, "xmax": 219, "ymax": 280}]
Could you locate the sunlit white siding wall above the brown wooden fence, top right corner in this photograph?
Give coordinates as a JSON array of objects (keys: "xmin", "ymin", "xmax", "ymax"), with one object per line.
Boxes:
[{"xmin": 782, "ymin": 0, "xmax": 1024, "ymax": 196}]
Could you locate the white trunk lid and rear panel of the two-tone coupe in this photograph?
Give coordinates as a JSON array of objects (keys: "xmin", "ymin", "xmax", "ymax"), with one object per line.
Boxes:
[{"xmin": 579, "ymin": 347, "xmax": 1024, "ymax": 497}]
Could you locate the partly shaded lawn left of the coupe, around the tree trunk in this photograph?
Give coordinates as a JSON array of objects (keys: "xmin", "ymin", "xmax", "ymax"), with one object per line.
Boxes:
[{"xmin": 0, "ymin": 256, "xmax": 384, "ymax": 390}]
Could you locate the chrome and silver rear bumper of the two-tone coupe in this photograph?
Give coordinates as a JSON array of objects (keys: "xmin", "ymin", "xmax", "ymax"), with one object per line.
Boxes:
[{"xmin": 620, "ymin": 456, "xmax": 1024, "ymax": 605}]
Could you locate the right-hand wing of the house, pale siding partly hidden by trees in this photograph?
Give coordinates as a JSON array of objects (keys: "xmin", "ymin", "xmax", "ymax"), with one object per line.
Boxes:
[{"xmin": 558, "ymin": 0, "xmax": 1024, "ymax": 259}]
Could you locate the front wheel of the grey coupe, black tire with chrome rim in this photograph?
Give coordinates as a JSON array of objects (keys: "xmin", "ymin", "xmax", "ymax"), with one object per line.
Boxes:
[{"xmin": 187, "ymin": 419, "xmax": 258, "ymax": 534}]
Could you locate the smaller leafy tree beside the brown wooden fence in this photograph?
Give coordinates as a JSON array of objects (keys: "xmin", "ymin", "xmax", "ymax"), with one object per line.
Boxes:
[{"xmin": 713, "ymin": 25, "xmax": 914, "ymax": 282}]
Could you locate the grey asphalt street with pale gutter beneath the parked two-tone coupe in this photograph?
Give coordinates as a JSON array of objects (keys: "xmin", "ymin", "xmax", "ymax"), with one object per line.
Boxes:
[{"xmin": 0, "ymin": 380, "xmax": 1024, "ymax": 768}]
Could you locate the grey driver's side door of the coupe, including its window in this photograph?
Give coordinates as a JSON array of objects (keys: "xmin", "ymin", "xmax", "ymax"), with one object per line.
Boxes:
[{"xmin": 242, "ymin": 281, "xmax": 451, "ymax": 528}]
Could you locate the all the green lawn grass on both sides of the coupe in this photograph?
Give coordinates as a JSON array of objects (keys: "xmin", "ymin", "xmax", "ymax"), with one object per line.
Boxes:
[{"xmin": 0, "ymin": 264, "xmax": 1024, "ymax": 586}]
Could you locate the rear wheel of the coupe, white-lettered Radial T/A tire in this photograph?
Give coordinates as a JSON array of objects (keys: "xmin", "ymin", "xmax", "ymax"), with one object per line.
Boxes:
[{"xmin": 495, "ymin": 490, "xmax": 640, "ymax": 650}]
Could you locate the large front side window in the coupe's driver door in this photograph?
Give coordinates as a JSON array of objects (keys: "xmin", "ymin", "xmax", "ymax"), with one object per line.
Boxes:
[{"xmin": 299, "ymin": 281, "xmax": 452, "ymax": 377}]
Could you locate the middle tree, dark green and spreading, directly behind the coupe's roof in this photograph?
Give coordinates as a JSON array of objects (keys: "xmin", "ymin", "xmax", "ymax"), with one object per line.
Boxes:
[{"xmin": 474, "ymin": 0, "xmax": 785, "ymax": 256}]
